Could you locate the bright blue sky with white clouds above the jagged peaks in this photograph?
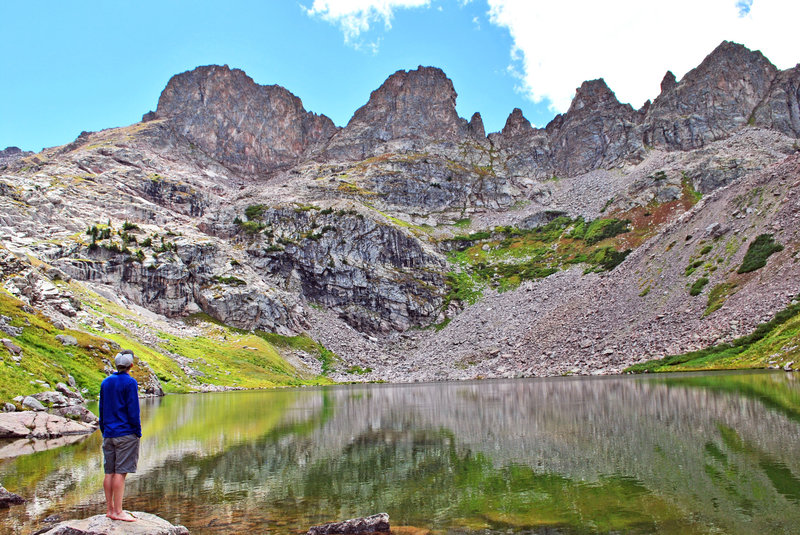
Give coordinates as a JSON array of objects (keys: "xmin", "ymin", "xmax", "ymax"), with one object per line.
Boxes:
[{"xmin": 0, "ymin": 0, "xmax": 800, "ymax": 151}]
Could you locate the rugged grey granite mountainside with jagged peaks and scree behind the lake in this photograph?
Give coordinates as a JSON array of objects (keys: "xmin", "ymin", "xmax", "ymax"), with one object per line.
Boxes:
[{"xmin": 0, "ymin": 42, "xmax": 800, "ymax": 388}]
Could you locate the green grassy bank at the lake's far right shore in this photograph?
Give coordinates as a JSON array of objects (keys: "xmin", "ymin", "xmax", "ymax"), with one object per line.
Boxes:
[{"xmin": 625, "ymin": 303, "xmax": 800, "ymax": 373}]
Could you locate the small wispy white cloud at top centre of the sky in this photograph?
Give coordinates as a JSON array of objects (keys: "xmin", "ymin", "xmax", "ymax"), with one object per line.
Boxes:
[{"xmin": 305, "ymin": 0, "xmax": 430, "ymax": 44}]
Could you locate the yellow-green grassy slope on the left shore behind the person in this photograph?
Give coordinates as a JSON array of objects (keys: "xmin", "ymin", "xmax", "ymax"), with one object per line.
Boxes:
[{"xmin": 0, "ymin": 283, "xmax": 330, "ymax": 401}]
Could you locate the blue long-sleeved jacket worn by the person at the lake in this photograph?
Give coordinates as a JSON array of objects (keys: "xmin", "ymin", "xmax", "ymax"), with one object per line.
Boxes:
[{"xmin": 100, "ymin": 372, "xmax": 142, "ymax": 438}]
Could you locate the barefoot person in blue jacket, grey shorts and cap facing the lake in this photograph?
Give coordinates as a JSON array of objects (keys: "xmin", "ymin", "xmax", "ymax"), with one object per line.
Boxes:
[{"xmin": 100, "ymin": 349, "xmax": 142, "ymax": 522}]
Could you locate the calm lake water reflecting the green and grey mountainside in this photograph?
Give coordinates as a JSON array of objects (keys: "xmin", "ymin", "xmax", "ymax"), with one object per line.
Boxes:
[{"xmin": 0, "ymin": 372, "xmax": 800, "ymax": 534}]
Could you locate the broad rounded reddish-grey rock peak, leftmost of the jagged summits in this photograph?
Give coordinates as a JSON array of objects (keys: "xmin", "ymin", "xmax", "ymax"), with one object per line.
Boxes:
[{"xmin": 152, "ymin": 65, "xmax": 337, "ymax": 175}]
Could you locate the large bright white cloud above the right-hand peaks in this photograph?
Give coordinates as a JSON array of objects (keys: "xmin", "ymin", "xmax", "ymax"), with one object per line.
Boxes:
[{"xmin": 488, "ymin": 0, "xmax": 800, "ymax": 111}]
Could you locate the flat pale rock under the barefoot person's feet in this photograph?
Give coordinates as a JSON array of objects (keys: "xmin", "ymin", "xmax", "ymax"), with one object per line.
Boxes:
[{"xmin": 42, "ymin": 511, "xmax": 189, "ymax": 535}]
